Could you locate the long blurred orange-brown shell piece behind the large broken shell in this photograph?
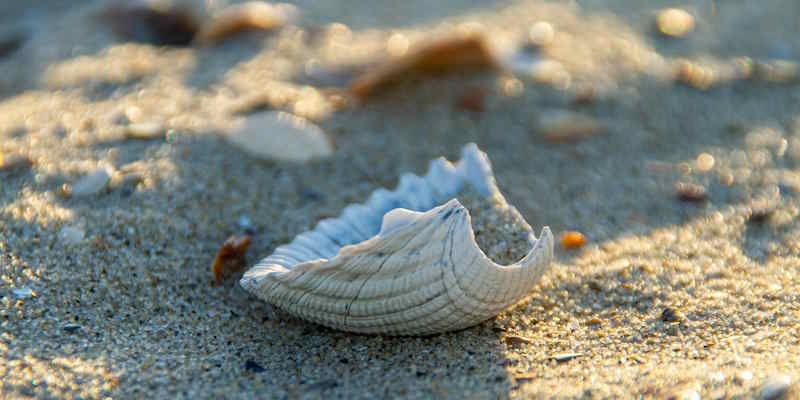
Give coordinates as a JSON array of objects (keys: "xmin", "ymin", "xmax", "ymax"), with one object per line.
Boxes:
[{"xmin": 350, "ymin": 33, "xmax": 498, "ymax": 100}]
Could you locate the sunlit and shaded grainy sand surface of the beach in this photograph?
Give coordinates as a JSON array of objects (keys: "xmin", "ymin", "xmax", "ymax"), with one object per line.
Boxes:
[{"xmin": 0, "ymin": 0, "xmax": 800, "ymax": 399}]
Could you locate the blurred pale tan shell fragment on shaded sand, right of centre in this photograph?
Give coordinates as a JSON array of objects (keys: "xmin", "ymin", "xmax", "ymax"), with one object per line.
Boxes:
[{"xmin": 537, "ymin": 110, "xmax": 608, "ymax": 143}]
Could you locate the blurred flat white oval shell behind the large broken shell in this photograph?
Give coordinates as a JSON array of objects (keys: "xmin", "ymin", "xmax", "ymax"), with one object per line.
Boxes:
[{"xmin": 226, "ymin": 111, "xmax": 333, "ymax": 162}]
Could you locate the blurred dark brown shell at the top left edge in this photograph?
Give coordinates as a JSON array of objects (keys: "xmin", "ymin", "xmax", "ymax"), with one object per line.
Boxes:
[{"xmin": 98, "ymin": 0, "xmax": 205, "ymax": 46}]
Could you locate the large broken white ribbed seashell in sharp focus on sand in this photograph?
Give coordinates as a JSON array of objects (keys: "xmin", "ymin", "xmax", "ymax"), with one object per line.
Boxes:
[{"xmin": 240, "ymin": 144, "xmax": 553, "ymax": 335}]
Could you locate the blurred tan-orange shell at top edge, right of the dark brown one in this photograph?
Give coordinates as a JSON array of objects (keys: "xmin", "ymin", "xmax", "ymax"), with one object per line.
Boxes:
[{"xmin": 195, "ymin": 1, "xmax": 298, "ymax": 46}]
